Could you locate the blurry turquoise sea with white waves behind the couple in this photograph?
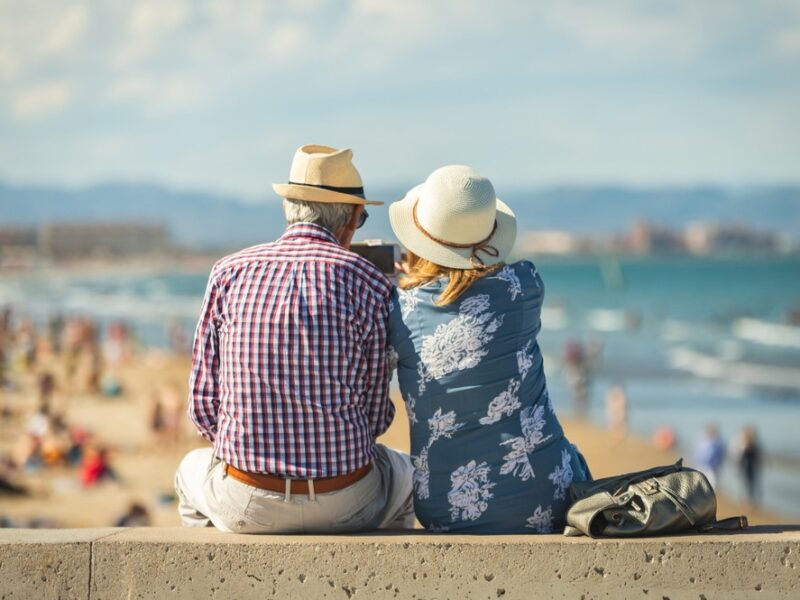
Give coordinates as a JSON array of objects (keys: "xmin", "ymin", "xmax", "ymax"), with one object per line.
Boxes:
[{"xmin": 0, "ymin": 256, "xmax": 800, "ymax": 519}]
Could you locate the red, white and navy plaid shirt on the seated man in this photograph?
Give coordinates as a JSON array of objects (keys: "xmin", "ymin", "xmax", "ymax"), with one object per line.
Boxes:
[{"xmin": 189, "ymin": 223, "xmax": 394, "ymax": 478}]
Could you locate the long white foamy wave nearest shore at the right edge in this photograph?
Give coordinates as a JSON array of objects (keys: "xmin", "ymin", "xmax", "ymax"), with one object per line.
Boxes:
[{"xmin": 668, "ymin": 346, "xmax": 800, "ymax": 390}]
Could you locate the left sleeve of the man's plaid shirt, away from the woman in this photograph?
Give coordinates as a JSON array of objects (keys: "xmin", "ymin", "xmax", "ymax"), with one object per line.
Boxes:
[{"xmin": 188, "ymin": 270, "xmax": 219, "ymax": 442}]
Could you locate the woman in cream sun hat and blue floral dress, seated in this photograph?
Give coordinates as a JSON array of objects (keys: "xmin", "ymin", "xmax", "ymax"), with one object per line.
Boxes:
[{"xmin": 389, "ymin": 166, "xmax": 588, "ymax": 533}]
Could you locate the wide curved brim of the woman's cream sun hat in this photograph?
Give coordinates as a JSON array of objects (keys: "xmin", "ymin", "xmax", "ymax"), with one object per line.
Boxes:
[{"xmin": 389, "ymin": 185, "xmax": 517, "ymax": 269}]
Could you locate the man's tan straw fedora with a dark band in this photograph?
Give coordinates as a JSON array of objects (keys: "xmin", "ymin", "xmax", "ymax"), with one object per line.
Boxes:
[{"xmin": 272, "ymin": 144, "xmax": 383, "ymax": 204}]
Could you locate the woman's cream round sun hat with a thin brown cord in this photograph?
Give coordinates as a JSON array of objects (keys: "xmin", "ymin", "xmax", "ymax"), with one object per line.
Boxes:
[{"xmin": 389, "ymin": 165, "xmax": 517, "ymax": 269}]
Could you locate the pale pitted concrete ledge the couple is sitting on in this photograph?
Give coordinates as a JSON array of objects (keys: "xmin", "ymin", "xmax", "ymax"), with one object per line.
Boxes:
[{"xmin": 0, "ymin": 526, "xmax": 800, "ymax": 600}]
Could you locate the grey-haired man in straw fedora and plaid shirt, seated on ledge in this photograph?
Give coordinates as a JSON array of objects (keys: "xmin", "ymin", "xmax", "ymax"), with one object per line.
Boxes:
[{"xmin": 175, "ymin": 145, "xmax": 414, "ymax": 533}]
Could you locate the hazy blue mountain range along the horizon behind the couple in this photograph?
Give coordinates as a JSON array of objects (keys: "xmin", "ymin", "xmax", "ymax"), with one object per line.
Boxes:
[{"xmin": 0, "ymin": 183, "xmax": 800, "ymax": 248}]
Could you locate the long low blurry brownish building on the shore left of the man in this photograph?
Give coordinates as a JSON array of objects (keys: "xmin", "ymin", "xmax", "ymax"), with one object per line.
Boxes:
[{"xmin": 38, "ymin": 223, "xmax": 168, "ymax": 259}]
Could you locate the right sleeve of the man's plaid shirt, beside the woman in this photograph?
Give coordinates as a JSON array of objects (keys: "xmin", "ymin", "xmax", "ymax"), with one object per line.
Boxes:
[{"xmin": 365, "ymin": 290, "xmax": 395, "ymax": 437}]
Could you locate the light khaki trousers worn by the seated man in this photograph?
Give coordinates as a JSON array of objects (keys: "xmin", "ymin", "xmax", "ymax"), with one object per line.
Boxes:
[{"xmin": 175, "ymin": 444, "xmax": 414, "ymax": 533}]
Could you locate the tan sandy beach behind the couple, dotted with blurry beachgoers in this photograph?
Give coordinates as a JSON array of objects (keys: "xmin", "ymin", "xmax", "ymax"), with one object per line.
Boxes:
[{"xmin": 0, "ymin": 351, "xmax": 792, "ymax": 527}]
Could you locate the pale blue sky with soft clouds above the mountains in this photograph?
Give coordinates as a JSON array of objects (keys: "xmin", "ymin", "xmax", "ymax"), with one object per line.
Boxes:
[{"xmin": 0, "ymin": 0, "xmax": 800, "ymax": 197}]
